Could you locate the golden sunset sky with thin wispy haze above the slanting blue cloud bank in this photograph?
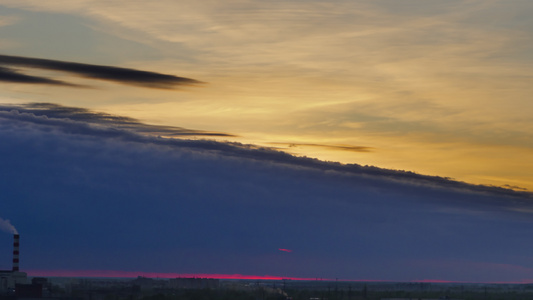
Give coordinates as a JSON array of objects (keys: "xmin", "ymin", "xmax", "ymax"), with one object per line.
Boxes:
[{"xmin": 0, "ymin": 0, "xmax": 533, "ymax": 189}]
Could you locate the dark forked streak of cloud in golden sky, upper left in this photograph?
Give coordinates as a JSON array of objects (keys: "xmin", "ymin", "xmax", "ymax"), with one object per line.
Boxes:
[{"xmin": 0, "ymin": 55, "xmax": 201, "ymax": 89}]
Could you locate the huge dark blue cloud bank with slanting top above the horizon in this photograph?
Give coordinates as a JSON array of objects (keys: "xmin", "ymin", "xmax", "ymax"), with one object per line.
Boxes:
[{"xmin": 0, "ymin": 104, "xmax": 533, "ymax": 281}]
